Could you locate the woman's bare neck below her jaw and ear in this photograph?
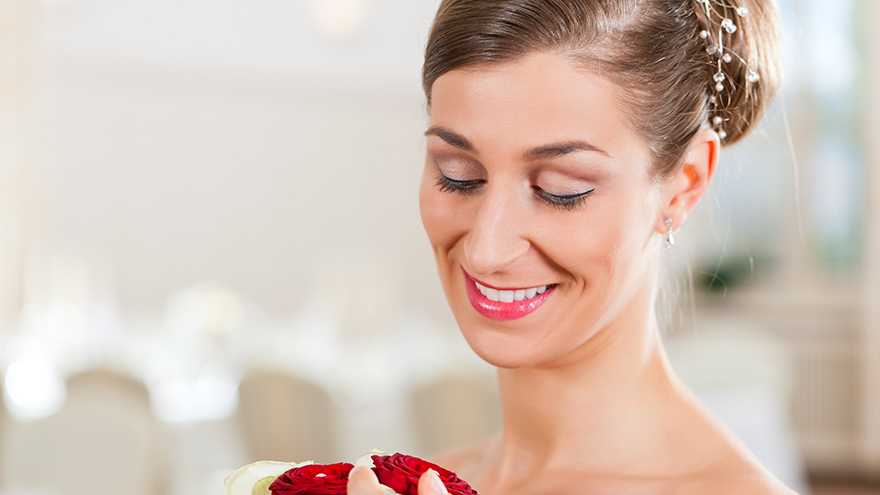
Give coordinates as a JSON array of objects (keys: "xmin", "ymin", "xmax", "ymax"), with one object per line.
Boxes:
[{"xmin": 492, "ymin": 280, "xmax": 677, "ymax": 485}]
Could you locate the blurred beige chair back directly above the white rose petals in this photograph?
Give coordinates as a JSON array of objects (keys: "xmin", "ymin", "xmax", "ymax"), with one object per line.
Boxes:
[{"xmin": 238, "ymin": 371, "xmax": 339, "ymax": 462}]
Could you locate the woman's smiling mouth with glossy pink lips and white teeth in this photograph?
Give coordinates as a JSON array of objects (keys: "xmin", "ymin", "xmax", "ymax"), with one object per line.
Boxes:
[{"xmin": 462, "ymin": 270, "xmax": 556, "ymax": 321}]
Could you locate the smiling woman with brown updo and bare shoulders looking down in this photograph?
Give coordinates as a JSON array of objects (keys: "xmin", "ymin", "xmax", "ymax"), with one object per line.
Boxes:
[{"xmin": 349, "ymin": 0, "xmax": 791, "ymax": 495}]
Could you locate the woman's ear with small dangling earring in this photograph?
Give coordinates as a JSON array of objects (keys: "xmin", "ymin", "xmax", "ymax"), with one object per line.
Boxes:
[{"xmin": 657, "ymin": 129, "xmax": 721, "ymax": 234}]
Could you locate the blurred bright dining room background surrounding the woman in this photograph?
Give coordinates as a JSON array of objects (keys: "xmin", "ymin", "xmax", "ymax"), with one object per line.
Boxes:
[{"xmin": 0, "ymin": 0, "xmax": 880, "ymax": 495}]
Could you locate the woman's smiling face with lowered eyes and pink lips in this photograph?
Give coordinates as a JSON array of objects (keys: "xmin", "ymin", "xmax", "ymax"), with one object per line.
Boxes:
[{"xmin": 420, "ymin": 53, "xmax": 662, "ymax": 368}]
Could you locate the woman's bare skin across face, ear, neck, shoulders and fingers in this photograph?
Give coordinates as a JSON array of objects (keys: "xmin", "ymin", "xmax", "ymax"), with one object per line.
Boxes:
[{"xmin": 349, "ymin": 53, "xmax": 793, "ymax": 495}]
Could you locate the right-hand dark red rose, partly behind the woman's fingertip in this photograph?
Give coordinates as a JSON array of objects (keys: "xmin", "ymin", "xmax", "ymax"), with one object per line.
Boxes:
[{"xmin": 372, "ymin": 454, "xmax": 477, "ymax": 495}]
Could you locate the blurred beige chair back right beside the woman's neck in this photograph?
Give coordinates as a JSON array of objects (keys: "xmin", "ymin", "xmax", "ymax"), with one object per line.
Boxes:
[{"xmin": 412, "ymin": 376, "xmax": 501, "ymax": 455}]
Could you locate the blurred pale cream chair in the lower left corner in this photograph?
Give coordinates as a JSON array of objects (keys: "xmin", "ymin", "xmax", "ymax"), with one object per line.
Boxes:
[{"xmin": 0, "ymin": 370, "xmax": 164, "ymax": 495}]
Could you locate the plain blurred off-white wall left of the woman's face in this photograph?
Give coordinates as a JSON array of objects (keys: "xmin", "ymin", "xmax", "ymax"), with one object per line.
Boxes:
[{"xmin": 36, "ymin": 0, "xmax": 448, "ymax": 314}]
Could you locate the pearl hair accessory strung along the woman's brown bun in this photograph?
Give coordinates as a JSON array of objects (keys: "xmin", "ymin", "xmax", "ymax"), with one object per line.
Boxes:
[{"xmin": 697, "ymin": 0, "xmax": 761, "ymax": 141}]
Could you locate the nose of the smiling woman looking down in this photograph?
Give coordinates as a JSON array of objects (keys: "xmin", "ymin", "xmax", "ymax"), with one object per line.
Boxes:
[{"xmin": 464, "ymin": 189, "xmax": 531, "ymax": 275}]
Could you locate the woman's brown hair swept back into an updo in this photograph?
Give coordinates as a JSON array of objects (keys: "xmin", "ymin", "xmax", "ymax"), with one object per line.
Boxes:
[{"xmin": 422, "ymin": 0, "xmax": 780, "ymax": 177}]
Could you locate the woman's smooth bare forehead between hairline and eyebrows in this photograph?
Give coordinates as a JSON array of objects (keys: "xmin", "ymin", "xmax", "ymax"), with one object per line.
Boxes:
[{"xmin": 431, "ymin": 53, "xmax": 647, "ymax": 163}]
